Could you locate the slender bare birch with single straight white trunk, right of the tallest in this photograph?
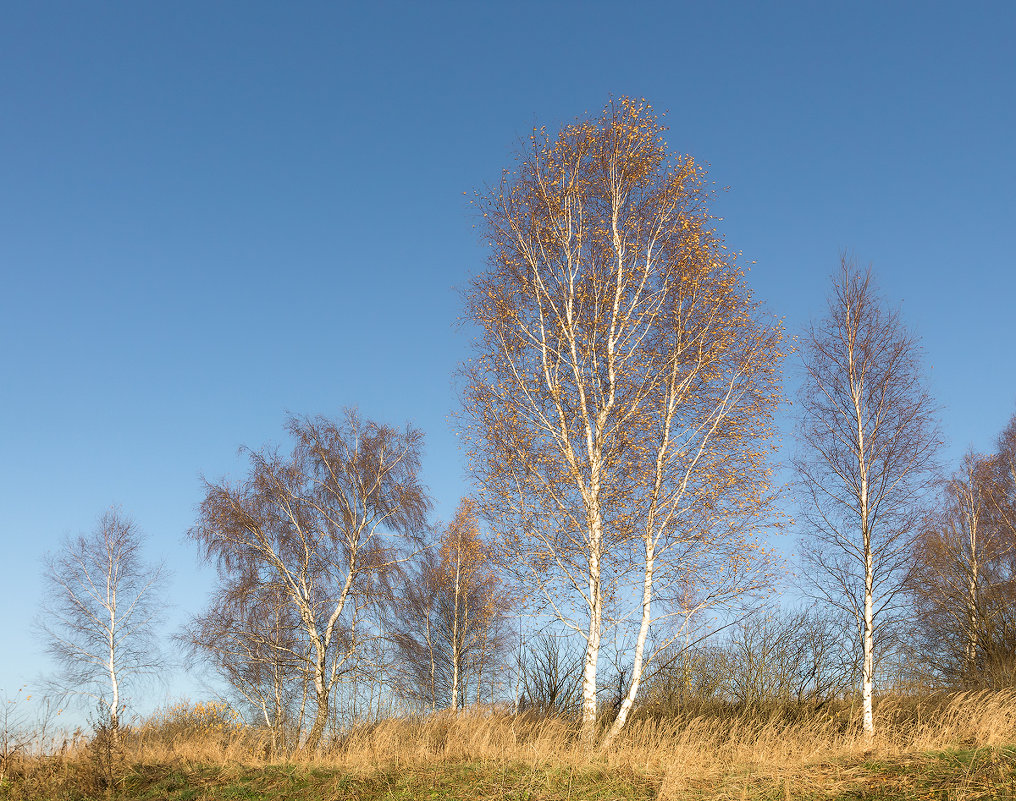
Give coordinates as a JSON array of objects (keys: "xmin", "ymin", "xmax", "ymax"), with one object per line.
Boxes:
[{"xmin": 795, "ymin": 256, "xmax": 939, "ymax": 738}]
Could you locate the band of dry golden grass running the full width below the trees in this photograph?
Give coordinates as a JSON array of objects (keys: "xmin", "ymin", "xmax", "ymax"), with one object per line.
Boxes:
[{"xmin": 0, "ymin": 691, "xmax": 1016, "ymax": 799}]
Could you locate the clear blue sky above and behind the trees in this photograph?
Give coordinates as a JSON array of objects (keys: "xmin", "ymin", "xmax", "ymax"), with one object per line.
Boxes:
[{"xmin": 0, "ymin": 1, "xmax": 1016, "ymax": 711}]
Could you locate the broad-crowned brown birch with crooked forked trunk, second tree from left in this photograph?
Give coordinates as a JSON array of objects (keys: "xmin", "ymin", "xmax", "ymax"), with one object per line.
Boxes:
[{"xmin": 190, "ymin": 412, "xmax": 430, "ymax": 750}]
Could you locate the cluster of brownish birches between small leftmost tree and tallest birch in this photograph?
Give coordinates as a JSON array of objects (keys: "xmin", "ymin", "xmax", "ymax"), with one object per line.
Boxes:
[{"xmin": 177, "ymin": 411, "xmax": 510, "ymax": 749}]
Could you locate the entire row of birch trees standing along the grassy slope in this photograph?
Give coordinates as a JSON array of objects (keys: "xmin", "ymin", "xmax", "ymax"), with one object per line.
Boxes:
[{"xmin": 35, "ymin": 98, "xmax": 1016, "ymax": 749}]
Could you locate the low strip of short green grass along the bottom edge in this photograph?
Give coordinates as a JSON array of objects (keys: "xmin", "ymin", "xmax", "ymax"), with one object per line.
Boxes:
[{"xmin": 0, "ymin": 747, "xmax": 1016, "ymax": 801}]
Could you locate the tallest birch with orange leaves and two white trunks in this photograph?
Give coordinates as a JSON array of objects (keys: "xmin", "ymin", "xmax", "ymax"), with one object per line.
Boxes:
[{"xmin": 463, "ymin": 99, "xmax": 782, "ymax": 745}]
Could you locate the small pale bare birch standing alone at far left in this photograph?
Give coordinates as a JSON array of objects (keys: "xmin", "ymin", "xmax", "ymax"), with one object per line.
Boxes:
[{"xmin": 38, "ymin": 508, "xmax": 165, "ymax": 732}]
